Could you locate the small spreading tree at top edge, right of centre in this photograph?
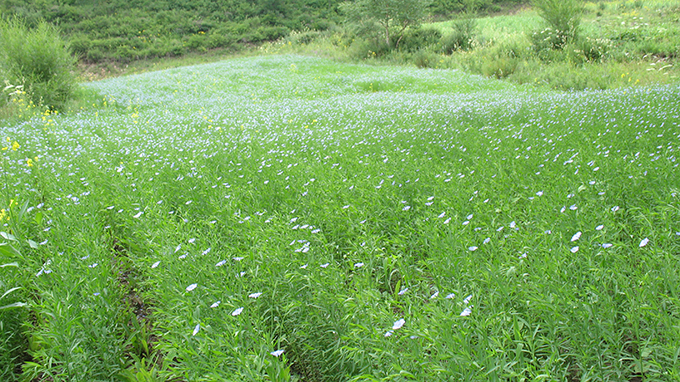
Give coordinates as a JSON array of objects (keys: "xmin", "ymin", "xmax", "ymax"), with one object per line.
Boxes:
[{"xmin": 341, "ymin": 0, "xmax": 429, "ymax": 47}]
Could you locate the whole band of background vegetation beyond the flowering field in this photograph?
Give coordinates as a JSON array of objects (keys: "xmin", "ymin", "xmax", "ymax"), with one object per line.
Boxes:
[{"xmin": 0, "ymin": 0, "xmax": 680, "ymax": 98}]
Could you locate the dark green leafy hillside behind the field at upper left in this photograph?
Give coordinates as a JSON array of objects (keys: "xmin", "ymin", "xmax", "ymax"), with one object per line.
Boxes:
[{"xmin": 0, "ymin": 0, "xmax": 348, "ymax": 63}]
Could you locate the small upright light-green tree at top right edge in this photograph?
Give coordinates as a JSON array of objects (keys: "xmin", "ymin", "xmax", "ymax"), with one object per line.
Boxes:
[{"xmin": 533, "ymin": 0, "xmax": 583, "ymax": 49}]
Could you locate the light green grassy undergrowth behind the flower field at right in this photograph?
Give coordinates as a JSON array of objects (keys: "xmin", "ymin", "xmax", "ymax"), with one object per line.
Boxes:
[{"xmin": 260, "ymin": 0, "xmax": 680, "ymax": 90}]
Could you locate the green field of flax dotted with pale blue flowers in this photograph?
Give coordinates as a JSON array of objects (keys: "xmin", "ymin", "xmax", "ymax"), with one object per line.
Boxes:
[{"xmin": 0, "ymin": 56, "xmax": 680, "ymax": 381}]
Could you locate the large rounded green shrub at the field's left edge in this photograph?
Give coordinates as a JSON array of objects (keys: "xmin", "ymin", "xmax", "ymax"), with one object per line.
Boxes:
[{"xmin": 0, "ymin": 18, "xmax": 76, "ymax": 109}]
